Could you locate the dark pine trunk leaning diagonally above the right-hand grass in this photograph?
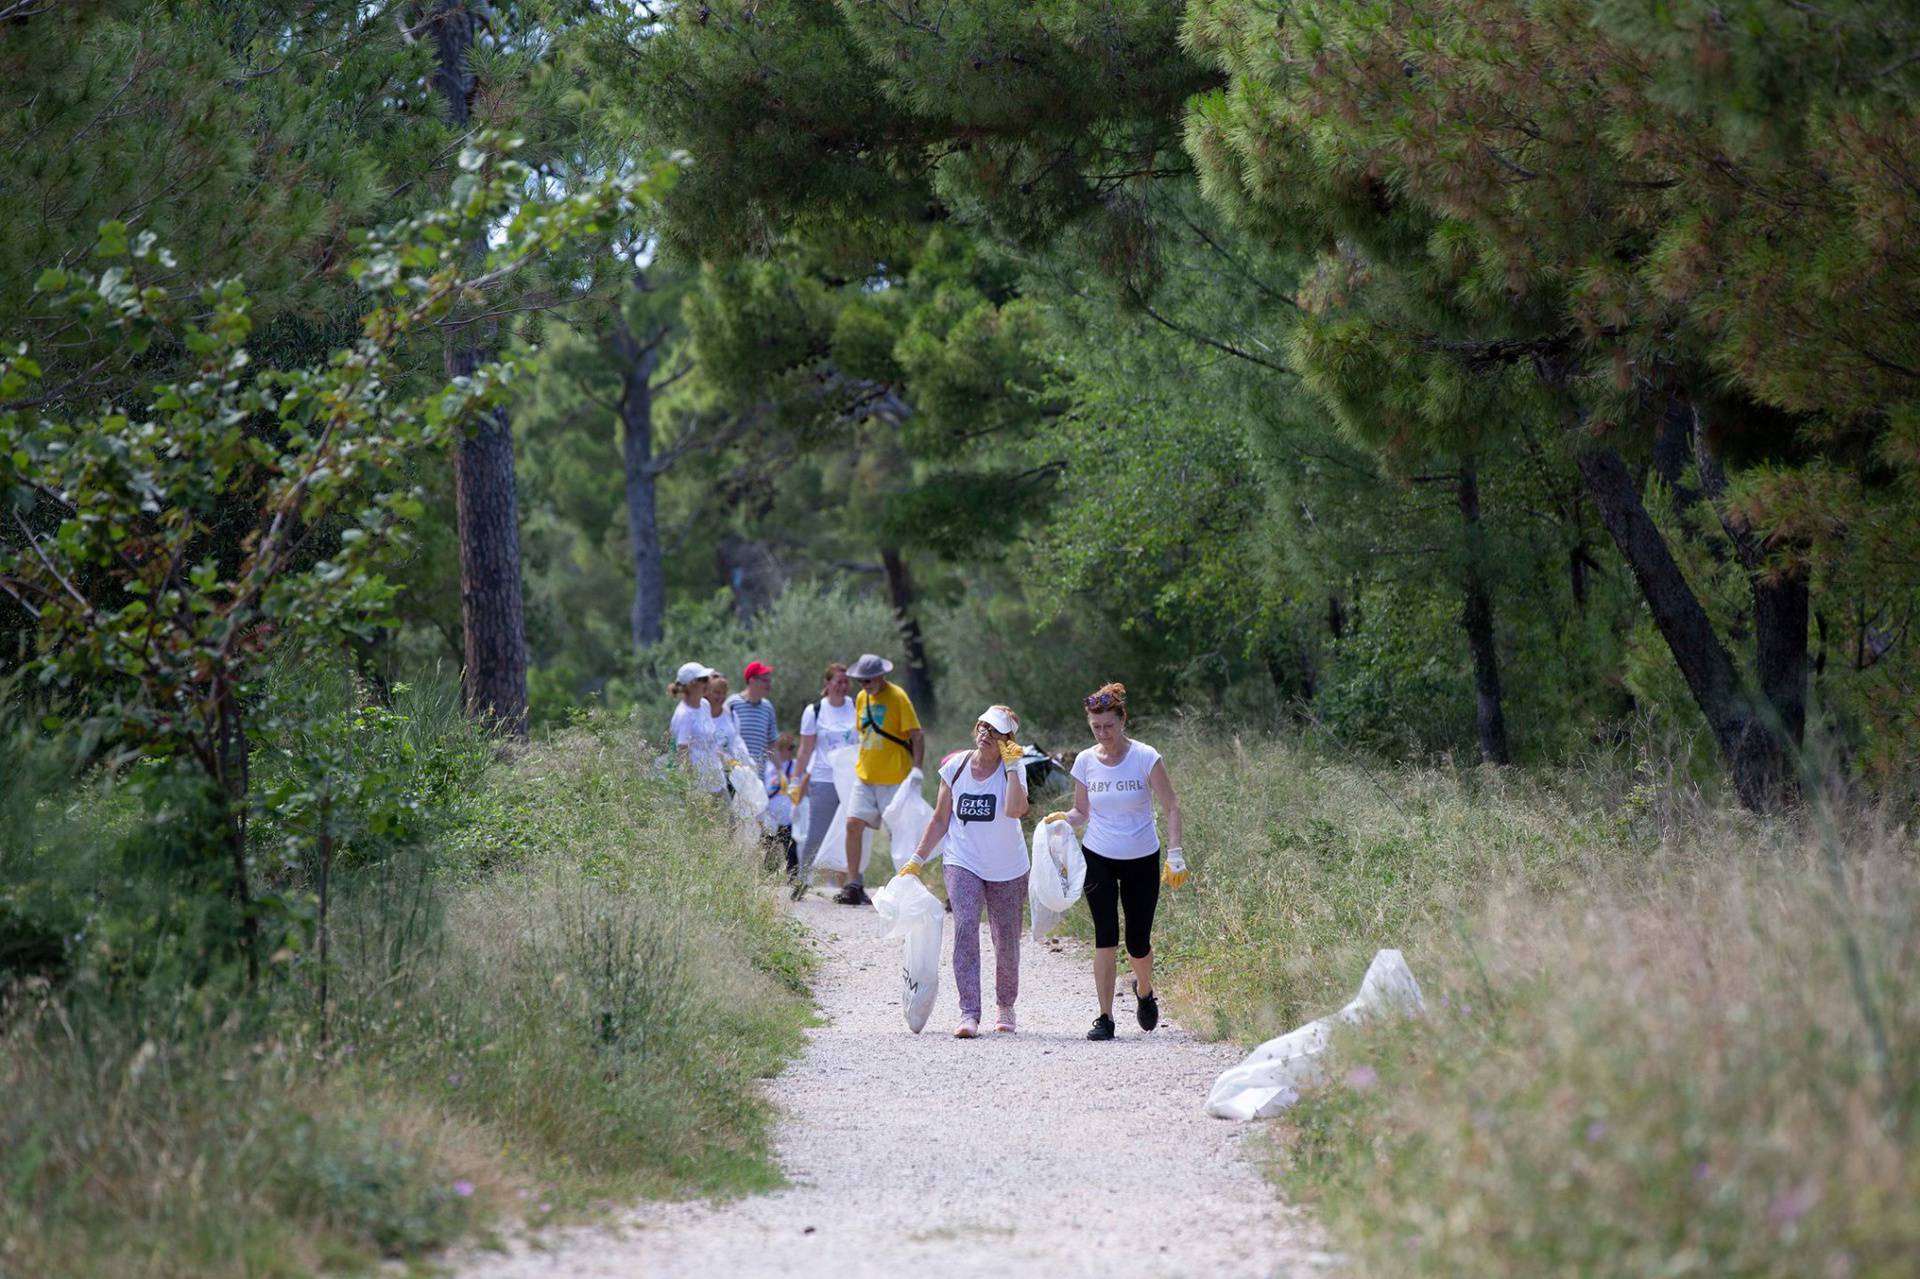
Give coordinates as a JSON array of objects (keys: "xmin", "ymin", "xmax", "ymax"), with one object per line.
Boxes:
[{"xmin": 1578, "ymin": 447, "xmax": 1781, "ymax": 812}]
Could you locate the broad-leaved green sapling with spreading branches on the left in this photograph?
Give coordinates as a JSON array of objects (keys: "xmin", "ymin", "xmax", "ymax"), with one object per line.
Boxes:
[{"xmin": 0, "ymin": 138, "xmax": 668, "ymax": 972}]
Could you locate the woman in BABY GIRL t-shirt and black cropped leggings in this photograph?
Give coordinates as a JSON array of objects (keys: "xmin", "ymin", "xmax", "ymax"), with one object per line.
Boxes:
[{"xmin": 1046, "ymin": 684, "xmax": 1187, "ymax": 1039}]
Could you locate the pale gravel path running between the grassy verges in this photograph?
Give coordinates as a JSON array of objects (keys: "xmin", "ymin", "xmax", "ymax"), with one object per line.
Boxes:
[{"xmin": 459, "ymin": 897, "xmax": 1331, "ymax": 1279}]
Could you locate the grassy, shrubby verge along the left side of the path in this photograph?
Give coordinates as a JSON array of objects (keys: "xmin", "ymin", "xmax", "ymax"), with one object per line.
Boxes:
[{"xmin": 0, "ymin": 702, "xmax": 810, "ymax": 1275}]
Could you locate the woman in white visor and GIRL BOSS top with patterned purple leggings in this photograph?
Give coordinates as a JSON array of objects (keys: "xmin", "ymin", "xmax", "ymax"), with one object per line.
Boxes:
[{"xmin": 900, "ymin": 707, "xmax": 1027, "ymax": 1039}]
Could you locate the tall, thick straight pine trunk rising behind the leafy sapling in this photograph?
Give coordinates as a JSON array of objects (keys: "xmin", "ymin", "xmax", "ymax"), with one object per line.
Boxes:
[{"xmin": 432, "ymin": 0, "xmax": 526, "ymax": 737}]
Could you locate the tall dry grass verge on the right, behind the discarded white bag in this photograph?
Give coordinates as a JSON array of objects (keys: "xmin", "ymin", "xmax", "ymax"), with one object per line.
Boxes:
[{"xmin": 1156, "ymin": 734, "xmax": 1920, "ymax": 1277}]
